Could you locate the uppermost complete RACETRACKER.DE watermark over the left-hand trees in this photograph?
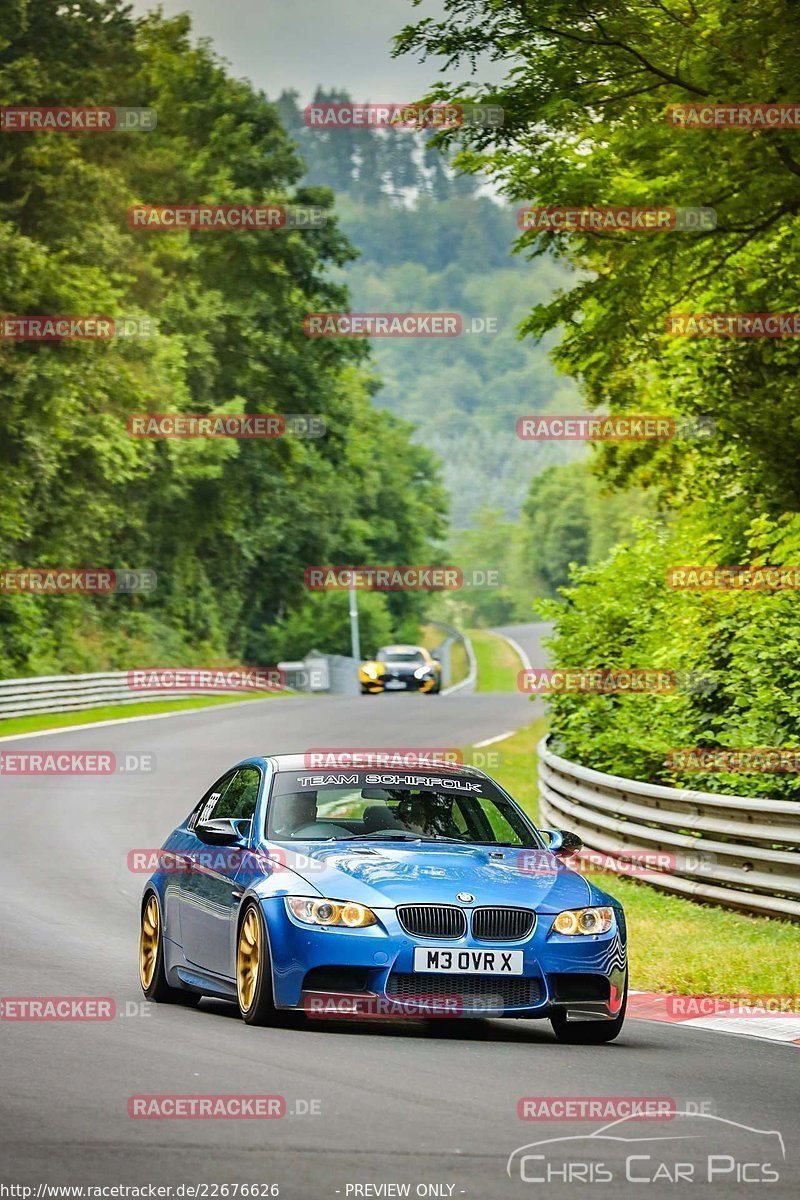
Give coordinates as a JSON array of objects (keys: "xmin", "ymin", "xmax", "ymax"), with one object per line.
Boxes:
[{"xmin": 127, "ymin": 204, "xmax": 327, "ymax": 226}]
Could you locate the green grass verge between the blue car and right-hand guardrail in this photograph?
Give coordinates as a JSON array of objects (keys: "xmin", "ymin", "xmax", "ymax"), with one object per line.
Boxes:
[{"xmin": 462, "ymin": 719, "xmax": 800, "ymax": 995}]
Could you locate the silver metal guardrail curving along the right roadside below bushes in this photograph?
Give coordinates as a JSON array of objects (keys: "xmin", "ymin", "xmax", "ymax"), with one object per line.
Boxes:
[{"xmin": 537, "ymin": 738, "xmax": 800, "ymax": 920}]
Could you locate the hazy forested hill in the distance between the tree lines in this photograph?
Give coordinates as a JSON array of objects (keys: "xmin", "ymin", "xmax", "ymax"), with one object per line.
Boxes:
[{"xmin": 277, "ymin": 91, "xmax": 582, "ymax": 528}]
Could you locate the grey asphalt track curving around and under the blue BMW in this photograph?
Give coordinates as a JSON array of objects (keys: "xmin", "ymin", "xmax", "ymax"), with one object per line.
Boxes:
[{"xmin": 0, "ymin": 695, "xmax": 799, "ymax": 1200}]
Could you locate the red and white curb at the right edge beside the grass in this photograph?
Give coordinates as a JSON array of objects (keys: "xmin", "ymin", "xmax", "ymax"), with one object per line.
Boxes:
[{"xmin": 626, "ymin": 991, "xmax": 800, "ymax": 1045}]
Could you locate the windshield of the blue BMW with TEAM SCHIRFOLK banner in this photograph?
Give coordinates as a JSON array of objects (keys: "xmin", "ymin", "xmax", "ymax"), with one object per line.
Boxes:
[{"xmin": 266, "ymin": 770, "xmax": 541, "ymax": 847}]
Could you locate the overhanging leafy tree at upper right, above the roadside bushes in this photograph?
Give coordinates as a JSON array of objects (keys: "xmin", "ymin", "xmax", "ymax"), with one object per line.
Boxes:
[{"xmin": 397, "ymin": 0, "xmax": 800, "ymax": 527}]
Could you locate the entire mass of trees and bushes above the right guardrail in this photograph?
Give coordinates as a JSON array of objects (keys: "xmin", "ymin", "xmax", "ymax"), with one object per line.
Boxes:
[{"xmin": 397, "ymin": 0, "xmax": 800, "ymax": 799}]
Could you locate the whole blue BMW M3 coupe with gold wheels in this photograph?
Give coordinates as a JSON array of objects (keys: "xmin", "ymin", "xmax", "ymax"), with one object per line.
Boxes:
[{"xmin": 139, "ymin": 751, "xmax": 627, "ymax": 1043}]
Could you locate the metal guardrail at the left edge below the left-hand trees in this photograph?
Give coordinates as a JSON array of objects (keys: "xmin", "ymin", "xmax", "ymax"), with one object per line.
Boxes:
[{"xmin": 0, "ymin": 671, "xmax": 263, "ymax": 720}]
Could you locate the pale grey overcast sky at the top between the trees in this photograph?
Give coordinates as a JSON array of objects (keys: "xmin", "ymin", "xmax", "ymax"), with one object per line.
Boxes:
[{"xmin": 133, "ymin": 0, "xmax": 482, "ymax": 102}]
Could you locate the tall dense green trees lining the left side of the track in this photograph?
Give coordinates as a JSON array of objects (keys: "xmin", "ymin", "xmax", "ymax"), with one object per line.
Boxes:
[{"xmin": 0, "ymin": 0, "xmax": 445, "ymax": 676}]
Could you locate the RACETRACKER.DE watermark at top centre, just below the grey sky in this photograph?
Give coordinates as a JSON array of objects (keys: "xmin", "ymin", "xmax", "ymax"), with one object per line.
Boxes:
[{"xmin": 303, "ymin": 101, "xmax": 505, "ymax": 132}]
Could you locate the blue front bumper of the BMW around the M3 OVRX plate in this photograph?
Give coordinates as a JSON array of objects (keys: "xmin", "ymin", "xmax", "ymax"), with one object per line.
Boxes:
[{"xmin": 263, "ymin": 898, "xmax": 627, "ymax": 1019}]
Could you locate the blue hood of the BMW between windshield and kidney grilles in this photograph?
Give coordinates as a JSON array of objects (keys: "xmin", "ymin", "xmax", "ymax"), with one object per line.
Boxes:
[{"xmin": 262, "ymin": 842, "xmax": 594, "ymax": 912}]
